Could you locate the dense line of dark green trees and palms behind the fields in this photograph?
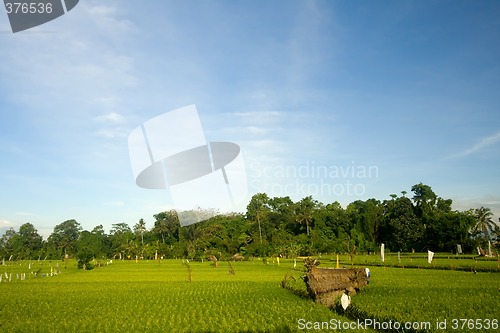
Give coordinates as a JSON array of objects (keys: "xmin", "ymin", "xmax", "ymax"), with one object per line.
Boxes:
[{"xmin": 0, "ymin": 183, "xmax": 500, "ymax": 267}]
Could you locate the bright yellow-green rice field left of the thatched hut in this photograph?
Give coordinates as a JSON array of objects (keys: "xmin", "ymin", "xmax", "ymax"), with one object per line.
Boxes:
[{"xmin": 0, "ymin": 260, "xmax": 376, "ymax": 332}]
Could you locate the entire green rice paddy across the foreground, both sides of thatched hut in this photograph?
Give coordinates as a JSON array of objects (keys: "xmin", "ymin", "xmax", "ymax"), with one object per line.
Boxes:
[{"xmin": 0, "ymin": 256, "xmax": 500, "ymax": 332}]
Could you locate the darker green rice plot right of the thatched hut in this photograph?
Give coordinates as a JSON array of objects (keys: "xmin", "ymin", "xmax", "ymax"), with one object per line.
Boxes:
[{"xmin": 347, "ymin": 267, "xmax": 500, "ymax": 332}]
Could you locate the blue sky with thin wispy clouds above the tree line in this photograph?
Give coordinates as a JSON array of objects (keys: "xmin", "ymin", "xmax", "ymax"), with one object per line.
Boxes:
[{"xmin": 0, "ymin": 0, "xmax": 500, "ymax": 236}]
